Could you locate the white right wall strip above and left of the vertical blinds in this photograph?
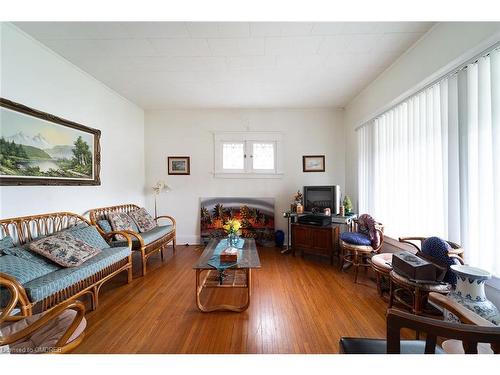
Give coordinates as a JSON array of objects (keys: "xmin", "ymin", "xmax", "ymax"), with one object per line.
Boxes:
[{"xmin": 344, "ymin": 22, "xmax": 500, "ymax": 207}]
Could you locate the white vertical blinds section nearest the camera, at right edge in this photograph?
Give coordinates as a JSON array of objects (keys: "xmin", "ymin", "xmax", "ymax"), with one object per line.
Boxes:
[{"xmin": 448, "ymin": 50, "xmax": 500, "ymax": 275}]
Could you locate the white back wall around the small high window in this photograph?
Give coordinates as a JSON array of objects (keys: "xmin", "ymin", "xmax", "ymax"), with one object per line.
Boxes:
[{"xmin": 145, "ymin": 109, "xmax": 345, "ymax": 243}]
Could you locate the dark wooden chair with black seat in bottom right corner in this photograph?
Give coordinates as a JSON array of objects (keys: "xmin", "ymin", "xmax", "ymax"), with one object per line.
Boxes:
[{"xmin": 339, "ymin": 293, "xmax": 500, "ymax": 354}]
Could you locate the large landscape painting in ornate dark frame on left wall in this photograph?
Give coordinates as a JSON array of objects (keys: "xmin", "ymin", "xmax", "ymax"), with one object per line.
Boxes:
[{"xmin": 0, "ymin": 98, "xmax": 101, "ymax": 185}]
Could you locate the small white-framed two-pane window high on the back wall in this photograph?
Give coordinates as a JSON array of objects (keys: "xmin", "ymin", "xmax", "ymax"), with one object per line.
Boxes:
[{"xmin": 215, "ymin": 132, "xmax": 283, "ymax": 178}]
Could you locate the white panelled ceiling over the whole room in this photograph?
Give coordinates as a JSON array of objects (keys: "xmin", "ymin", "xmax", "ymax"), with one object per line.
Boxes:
[{"xmin": 15, "ymin": 22, "xmax": 432, "ymax": 109}]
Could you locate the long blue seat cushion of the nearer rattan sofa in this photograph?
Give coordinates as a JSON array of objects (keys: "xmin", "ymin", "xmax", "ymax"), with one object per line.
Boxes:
[{"xmin": 24, "ymin": 247, "xmax": 130, "ymax": 302}]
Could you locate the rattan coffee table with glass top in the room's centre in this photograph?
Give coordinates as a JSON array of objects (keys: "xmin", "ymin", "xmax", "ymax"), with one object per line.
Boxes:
[{"xmin": 193, "ymin": 238, "xmax": 260, "ymax": 312}]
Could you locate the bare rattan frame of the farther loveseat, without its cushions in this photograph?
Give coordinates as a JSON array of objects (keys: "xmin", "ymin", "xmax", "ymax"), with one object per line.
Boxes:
[{"xmin": 89, "ymin": 204, "xmax": 176, "ymax": 276}]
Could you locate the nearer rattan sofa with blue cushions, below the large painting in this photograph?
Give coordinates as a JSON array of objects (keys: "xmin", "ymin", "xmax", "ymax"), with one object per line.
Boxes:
[{"xmin": 0, "ymin": 212, "xmax": 132, "ymax": 316}]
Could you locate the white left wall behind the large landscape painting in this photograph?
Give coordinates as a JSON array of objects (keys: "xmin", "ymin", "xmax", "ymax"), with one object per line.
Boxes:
[{"xmin": 0, "ymin": 23, "xmax": 145, "ymax": 218}]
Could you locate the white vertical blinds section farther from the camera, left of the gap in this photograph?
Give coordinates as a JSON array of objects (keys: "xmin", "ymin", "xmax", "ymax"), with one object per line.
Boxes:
[{"xmin": 358, "ymin": 84, "xmax": 447, "ymax": 238}]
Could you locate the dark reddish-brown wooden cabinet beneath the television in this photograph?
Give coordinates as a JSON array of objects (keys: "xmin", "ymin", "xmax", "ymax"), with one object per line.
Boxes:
[{"xmin": 291, "ymin": 224, "xmax": 339, "ymax": 264}]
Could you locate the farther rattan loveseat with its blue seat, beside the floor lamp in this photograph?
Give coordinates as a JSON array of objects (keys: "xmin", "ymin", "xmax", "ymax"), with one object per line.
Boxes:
[{"xmin": 89, "ymin": 204, "xmax": 175, "ymax": 276}]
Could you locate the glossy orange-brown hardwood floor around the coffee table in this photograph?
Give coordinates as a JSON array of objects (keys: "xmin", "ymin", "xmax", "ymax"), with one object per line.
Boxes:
[{"xmin": 75, "ymin": 246, "xmax": 387, "ymax": 353}]
